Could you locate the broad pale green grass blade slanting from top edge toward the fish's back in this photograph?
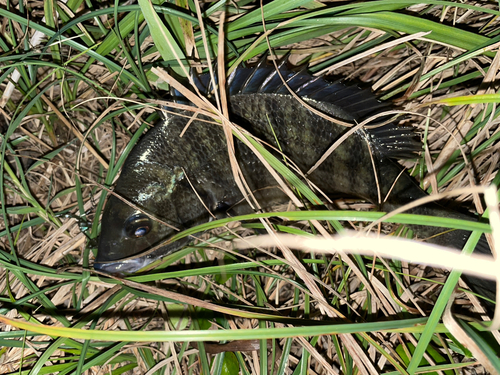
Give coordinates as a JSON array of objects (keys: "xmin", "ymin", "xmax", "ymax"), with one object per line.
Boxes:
[{"xmin": 139, "ymin": 0, "xmax": 189, "ymax": 77}]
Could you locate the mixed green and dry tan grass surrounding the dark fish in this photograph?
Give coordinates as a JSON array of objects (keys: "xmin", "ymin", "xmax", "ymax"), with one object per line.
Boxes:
[{"xmin": 0, "ymin": 0, "xmax": 500, "ymax": 375}]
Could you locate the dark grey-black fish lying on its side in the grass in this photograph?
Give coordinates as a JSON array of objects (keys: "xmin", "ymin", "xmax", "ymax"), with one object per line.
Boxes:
[{"xmin": 94, "ymin": 59, "xmax": 496, "ymax": 306}]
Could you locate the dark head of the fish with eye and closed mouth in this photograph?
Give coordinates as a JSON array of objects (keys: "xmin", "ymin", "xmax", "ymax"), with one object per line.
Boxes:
[{"xmin": 94, "ymin": 163, "xmax": 186, "ymax": 275}]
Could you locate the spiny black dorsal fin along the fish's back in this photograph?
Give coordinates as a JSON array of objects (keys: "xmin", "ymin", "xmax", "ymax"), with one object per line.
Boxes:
[{"xmin": 182, "ymin": 57, "xmax": 421, "ymax": 159}]
